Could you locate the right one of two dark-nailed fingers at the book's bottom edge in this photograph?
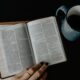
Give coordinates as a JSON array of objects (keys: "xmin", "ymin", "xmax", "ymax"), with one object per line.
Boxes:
[{"xmin": 29, "ymin": 64, "xmax": 48, "ymax": 80}]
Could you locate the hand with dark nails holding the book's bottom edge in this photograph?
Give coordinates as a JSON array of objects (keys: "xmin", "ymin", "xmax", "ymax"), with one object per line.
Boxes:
[{"xmin": 14, "ymin": 62, "xmax": 48, "ymax": 80}]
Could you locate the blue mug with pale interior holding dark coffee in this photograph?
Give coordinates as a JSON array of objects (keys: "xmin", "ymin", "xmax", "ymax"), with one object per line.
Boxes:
[{"xmin": 56, "ymin": 5, "xmax": 80, "ymax": 41}]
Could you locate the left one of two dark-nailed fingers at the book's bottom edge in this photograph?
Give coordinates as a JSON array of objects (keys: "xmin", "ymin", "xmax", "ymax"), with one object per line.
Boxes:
[{"xmin": 21, "ymin": 64, "xmax": 42, "ymax": 80}]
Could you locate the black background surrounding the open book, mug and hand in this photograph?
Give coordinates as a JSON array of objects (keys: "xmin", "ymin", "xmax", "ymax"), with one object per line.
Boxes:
[{"xmin": 0, "ymin": 0, "xmax": 80, "ymax": 80}]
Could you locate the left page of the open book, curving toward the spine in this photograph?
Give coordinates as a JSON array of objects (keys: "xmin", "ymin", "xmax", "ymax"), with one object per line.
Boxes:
[{"xmin": 0, "ymin": 24, "xmax": 33, "ymax": 77}]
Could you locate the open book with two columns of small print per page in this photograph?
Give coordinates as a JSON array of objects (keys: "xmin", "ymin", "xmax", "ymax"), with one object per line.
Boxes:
[{"xmin": 0, "ymin": 17, "xmax": 66, "ymax": 78}]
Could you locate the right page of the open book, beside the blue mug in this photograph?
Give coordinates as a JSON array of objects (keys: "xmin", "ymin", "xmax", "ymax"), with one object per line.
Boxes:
[{"xmin": 28, "ymin": 17, "xmax": 66, "ymax": 65}]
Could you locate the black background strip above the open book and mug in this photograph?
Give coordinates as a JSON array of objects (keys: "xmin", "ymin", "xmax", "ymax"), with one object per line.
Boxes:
[{"xmin": 0, "ymin": 0, "xmax": 80, "ymax": 21}]
